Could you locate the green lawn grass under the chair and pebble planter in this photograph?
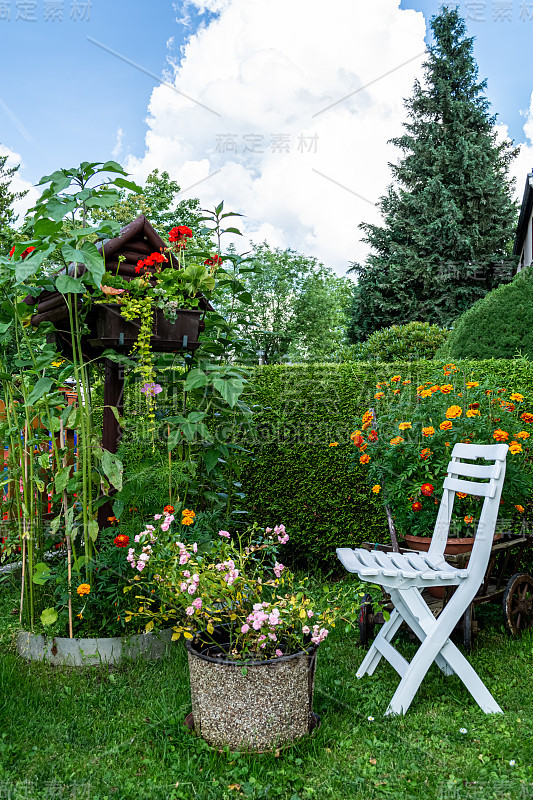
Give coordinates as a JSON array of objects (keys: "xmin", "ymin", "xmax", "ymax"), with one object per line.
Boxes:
[{"xmin": 0, "ymin": 572, "xmax": 533, "ymax": 800}]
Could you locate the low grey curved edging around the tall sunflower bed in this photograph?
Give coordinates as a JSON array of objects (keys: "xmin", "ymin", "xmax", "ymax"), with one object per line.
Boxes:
[{"xmin": 17, "ymin": 630, "xmax": 172, "ymax": 667}]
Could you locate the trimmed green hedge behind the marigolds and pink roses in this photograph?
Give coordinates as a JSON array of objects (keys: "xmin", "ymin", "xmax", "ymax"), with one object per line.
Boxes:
[{"xmin": 240, "ymin": 359, "xmax": 533, "ymax": 567}]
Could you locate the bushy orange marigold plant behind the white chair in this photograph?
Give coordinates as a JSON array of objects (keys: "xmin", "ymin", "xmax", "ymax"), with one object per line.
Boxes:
[{"xmin": 351, "ymin": 364, "xmax": 533, "ymax": 536}]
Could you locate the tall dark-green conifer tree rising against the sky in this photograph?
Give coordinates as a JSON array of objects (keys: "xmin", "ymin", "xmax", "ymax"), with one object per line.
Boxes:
[{"xmin": 349, "ymin": 7, "xmax": 518, "ymax": 342}]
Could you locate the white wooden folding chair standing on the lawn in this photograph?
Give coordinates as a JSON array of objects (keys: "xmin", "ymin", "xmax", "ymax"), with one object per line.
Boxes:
[{"xmin": 337, "ymin": 444, "xmax": 508, "ymax": 714}]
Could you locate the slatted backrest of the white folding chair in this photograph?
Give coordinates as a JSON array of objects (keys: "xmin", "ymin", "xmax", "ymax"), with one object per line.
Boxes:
[{"xmin": 429, "ymin": 443, "xmax": 509, "ymax": 576}]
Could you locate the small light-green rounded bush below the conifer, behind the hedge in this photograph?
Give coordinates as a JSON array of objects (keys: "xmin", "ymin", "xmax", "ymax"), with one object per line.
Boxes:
[{"xmin": 358, "ymin": 322, "xmax": 449, "ymax": 361}]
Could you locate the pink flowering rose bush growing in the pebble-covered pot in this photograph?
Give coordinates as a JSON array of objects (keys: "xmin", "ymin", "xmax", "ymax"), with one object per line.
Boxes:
[{"xmin": 127, "ymin": 513, "xmax": 364, "ymax": 661}]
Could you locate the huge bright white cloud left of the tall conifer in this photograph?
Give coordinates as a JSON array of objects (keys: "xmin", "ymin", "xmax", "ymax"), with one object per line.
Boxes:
[{"xmin": 127, "ymin": 0, "xmax": 426, "ymax": 273}]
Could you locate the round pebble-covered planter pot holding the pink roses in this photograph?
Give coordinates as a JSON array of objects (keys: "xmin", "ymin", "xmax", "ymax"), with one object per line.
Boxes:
[{"xmin": 186, "ymin": 641, "xmax": 317, "ymax": 751}]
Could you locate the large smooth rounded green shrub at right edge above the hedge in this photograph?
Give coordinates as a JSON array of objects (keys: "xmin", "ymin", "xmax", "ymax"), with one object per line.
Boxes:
[{"xmin": 439, "ymin": 269, "xmax": 533, "ymax": 360}]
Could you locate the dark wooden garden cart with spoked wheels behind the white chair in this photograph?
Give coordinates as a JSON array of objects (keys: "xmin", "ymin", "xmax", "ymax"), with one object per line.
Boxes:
[{"xmin": 359, "ymin": 533, "xmax": 533, "ymax": 651}]
